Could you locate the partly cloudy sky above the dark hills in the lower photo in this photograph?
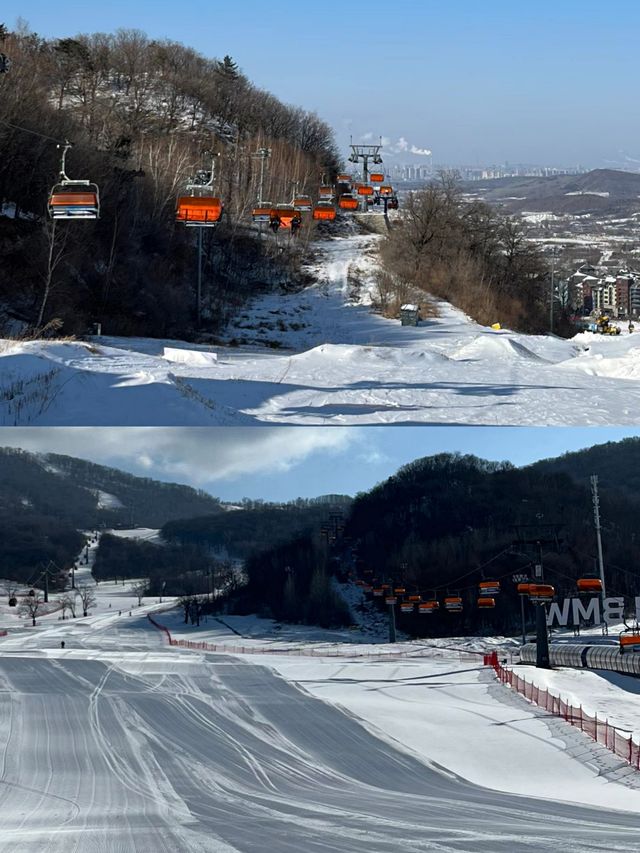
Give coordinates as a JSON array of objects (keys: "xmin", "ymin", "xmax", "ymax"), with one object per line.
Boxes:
[{"xmin": 0, "ymin": 426, "xmax": 640, "ymax": 501}]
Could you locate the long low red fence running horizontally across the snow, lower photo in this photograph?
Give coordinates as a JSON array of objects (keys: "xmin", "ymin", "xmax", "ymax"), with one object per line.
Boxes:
[{"xmin": 147, "ymin": 614, "xmax": 497, "ymax": 666}]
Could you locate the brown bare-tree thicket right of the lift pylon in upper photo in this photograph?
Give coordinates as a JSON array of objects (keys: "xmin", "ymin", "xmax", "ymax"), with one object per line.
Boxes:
[{"xmin": 380, "ymin": 174, "xmax": 552, "ymax": 333}]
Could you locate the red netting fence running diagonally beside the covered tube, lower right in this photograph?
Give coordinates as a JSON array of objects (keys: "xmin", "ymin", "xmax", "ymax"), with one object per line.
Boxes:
[{"xmin": 492, "ymin": 656, "xmax": 640, "ymax": 770}]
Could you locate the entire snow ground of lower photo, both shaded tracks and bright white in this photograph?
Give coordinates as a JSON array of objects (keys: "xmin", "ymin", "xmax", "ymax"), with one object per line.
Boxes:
[{"xmin": 0, "ymin": 554, "xmax": 640, "ymax": 853}]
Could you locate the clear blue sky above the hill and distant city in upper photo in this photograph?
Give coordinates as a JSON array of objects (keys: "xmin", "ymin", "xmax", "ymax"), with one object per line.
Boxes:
[{"xmin": 8, "ymin": 0, "xmax": 640, "ymax": 166}]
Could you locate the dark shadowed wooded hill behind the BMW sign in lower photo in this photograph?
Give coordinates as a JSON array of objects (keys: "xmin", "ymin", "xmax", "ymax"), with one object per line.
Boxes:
[{"xmin": 231, "ymin": 450, "xmax": 640, "ymax": 636}]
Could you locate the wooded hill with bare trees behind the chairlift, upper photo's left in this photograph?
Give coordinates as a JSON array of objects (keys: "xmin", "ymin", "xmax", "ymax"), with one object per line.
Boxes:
[{"xmin": 0, "ymin": 23, "xmax": 338, "ymax": 337}]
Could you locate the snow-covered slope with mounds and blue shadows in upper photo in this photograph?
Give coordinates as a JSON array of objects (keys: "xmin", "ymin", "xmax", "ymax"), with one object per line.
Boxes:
[{"xmin": 6, "ymin": 228, "xmax": 640, "ymax": 426}]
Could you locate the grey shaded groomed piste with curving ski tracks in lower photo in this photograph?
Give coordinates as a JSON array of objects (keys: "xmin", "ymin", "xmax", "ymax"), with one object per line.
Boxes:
[{"xmin": 0, "ymin": 614, "xmax": 637, "ymax": 853}]
